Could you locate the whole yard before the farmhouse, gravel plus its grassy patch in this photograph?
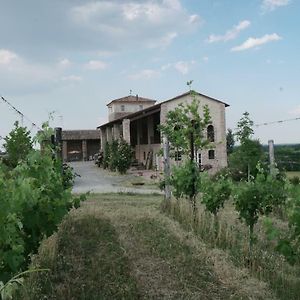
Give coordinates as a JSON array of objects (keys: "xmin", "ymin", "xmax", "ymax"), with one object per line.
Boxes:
[{"xmin": 70, "ymin": 161, "xmax": 160, "ymax": 194}]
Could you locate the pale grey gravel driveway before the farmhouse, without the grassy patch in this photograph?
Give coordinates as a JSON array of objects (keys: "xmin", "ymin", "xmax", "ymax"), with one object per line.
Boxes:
[{"xmin": 69, "ymin": 161, "xmax": 160, "ymax": 194}]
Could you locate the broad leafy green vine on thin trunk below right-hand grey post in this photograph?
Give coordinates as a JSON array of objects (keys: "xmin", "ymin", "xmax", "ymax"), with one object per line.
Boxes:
[{"xmin": 234, "ymin": 166, "xmax": 288, "ymax": 246}]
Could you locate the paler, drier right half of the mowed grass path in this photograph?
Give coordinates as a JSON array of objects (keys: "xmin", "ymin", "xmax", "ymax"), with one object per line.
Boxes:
[{"xmin": 86, "ymin": 195, "xmax": 275, "ymax": 299}]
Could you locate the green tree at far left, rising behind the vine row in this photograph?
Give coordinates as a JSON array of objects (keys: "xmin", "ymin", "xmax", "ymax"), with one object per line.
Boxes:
[{"xmin": 4, "ymin": 122, "xmax": 32, "ymax": 168}]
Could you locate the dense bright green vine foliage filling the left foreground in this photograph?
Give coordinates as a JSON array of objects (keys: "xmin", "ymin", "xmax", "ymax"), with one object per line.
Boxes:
[{"xmin": 0, "ymin": 122, "xmax": 83, "ymax": 282}]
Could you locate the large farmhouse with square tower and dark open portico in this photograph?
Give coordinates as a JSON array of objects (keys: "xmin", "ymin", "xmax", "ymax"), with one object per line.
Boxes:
[{"xmin": 97, "ymin": 92, "xmax": 229, "ymax": 172}]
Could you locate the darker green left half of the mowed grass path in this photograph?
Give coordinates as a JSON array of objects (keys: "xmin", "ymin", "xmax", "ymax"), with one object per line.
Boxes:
[{"xmin": 22, "ymin": 214, "xmax": 139, "ymax": 300}]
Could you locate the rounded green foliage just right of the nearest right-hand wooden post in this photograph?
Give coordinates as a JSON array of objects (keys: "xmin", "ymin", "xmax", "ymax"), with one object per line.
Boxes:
[{"xmin": 170, "ymin": 160, "xmax": 200, "ymax": 199}]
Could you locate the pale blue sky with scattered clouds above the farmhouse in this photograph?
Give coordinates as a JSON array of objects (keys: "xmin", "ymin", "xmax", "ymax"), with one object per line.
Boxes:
[{"xmin": 0, "ymin": 0, "xmax": 300, "ymax": 149}]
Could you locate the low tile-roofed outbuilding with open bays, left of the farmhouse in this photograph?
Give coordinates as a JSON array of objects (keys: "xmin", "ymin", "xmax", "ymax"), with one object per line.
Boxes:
[{"xmin": 62, "ymin": 130, "xmax": 100, "ymax": 161}]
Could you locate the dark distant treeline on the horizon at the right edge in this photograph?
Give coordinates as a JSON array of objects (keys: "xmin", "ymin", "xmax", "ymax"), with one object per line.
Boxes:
[{"xmin": 263, "ymin": 144, "xmax": 300, "ymax": 171}]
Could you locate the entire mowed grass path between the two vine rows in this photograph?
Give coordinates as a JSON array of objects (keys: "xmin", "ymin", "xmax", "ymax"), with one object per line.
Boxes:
[{"xmin": 21, "ymin": 194, "xmax": 275, "ymax": 300}]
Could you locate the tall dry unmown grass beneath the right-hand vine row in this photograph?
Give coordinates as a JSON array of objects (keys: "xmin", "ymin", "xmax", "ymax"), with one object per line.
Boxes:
[{"xmin": 165, "ymin": 199, "xmax": 300, "ymax": 300}]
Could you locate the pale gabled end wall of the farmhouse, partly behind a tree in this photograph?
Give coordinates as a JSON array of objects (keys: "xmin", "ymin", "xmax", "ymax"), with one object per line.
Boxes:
[{"xmin": 160, "ymin": 95, "xmax": 227, "ymax": 172}]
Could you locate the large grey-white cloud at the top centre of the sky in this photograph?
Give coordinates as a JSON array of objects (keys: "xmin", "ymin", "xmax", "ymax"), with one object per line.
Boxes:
[{"xmin": 70, "ymin": 0, "xmax": 201, "ymax": 50}]
